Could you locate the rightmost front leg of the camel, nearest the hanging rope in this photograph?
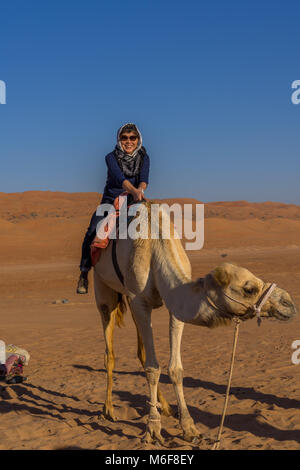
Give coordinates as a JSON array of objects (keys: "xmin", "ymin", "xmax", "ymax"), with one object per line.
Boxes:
[{"xmin": 169, "ymin": 313, "xmax": 200, "ymax": 442}]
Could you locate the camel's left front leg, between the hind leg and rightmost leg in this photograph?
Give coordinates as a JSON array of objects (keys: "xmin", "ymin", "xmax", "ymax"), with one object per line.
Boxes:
[{"xmin": 130, "ymin": 298, "xmax": 163, "ymax": 443}]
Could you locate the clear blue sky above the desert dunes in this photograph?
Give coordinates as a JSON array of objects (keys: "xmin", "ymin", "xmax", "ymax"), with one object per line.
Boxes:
[{"xmin": 0, "ymin": 0, "xmax": 300, "ymax": 204}]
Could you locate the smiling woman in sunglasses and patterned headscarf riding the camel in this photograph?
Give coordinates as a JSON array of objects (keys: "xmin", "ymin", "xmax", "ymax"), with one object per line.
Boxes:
[{"xmin": 77, "ymin": 123, "xmax": 150, "ymax": 294}]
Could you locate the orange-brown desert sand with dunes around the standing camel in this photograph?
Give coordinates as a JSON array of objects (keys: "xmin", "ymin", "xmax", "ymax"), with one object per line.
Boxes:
[{"xmin": 0, "ymin": 191, "xmax": 300, "ymax": 450}]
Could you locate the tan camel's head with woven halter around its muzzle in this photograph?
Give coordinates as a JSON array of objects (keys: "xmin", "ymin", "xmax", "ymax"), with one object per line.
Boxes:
[{"xmin": 204, "ymin": 263, "xmax": 297, "ymax": 321}]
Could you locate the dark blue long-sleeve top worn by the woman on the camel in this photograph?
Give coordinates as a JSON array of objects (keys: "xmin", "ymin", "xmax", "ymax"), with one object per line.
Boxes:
[{"xmin": 102, "ymin": 152, "xmax": 150, "ymax": 204}]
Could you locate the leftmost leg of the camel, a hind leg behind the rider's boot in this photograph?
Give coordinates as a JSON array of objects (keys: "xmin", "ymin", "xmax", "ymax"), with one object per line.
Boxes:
[{"xmin": 94, "ymin": 272, "xmax": 120, "ymax": 421}]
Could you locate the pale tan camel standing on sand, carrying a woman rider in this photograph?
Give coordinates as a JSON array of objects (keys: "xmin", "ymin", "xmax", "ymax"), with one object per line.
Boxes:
[{"xmin": 94, "ymin": 202, "xmax": 297, "ymax": 443}]
